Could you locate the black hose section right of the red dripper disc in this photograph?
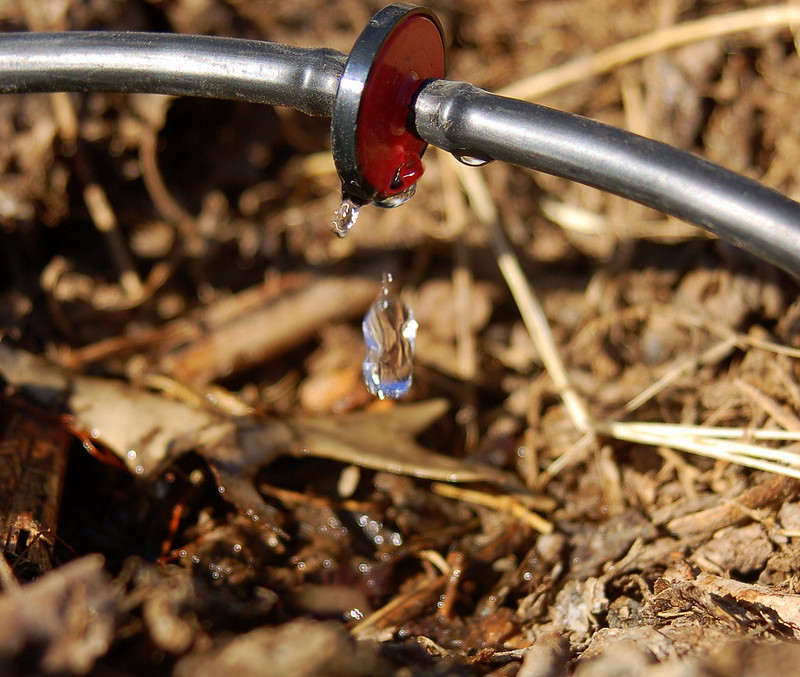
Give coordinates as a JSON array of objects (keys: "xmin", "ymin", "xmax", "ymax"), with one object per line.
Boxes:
[{"xmin": 415, "ymin": 80, "xmax": 800, "ymax": 278}]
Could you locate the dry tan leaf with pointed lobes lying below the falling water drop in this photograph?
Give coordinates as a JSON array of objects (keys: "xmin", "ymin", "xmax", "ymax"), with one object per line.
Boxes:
[{"xmin": 0, "ymin": 343, "xmax": 511, "ymax": 536}]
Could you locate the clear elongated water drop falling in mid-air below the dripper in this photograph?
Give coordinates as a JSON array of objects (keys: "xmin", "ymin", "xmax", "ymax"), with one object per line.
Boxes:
[{"xmin": 361, "ymin": 273, "xmax": 418, "ymax": 400}]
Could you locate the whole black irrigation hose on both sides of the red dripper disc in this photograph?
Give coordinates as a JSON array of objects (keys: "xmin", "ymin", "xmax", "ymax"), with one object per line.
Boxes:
[{"xmin": 0, "ymin": 32, "xmax": 800, "ymax": 278}]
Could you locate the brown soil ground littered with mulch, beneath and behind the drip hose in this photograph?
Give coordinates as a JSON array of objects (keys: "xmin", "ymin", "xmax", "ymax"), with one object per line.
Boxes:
[{"xmin": 0, "ymin": 0, "xmax": 800, "ymax": 677}]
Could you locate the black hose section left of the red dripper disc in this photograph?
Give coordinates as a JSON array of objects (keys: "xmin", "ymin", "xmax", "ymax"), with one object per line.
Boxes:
[{"xmin": 0, "ymin": 31, "xmax": 347, "ymax": 116}]
